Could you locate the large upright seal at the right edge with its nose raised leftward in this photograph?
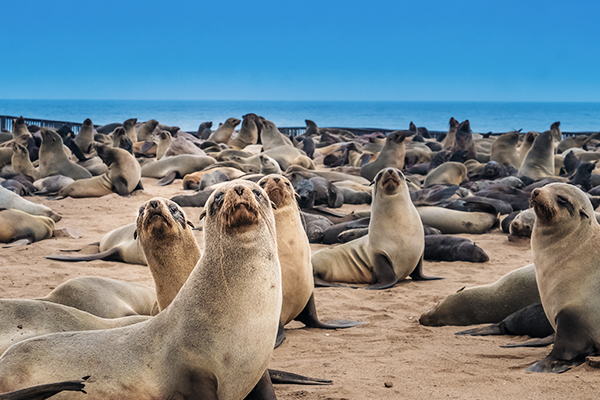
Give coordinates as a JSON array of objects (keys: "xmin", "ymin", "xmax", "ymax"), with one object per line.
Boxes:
[{"xmin": 527, "ymin": 183, "xmax": 600, "ymax": 372}]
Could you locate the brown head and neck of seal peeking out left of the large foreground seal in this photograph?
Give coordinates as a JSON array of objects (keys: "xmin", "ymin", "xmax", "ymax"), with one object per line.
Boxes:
[{"xmin": 135, "ymin": 197, "xmax": 201, "ymax": 311}]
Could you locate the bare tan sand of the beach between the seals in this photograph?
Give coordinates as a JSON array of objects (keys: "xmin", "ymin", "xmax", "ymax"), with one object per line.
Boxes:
[{"xmin": 0, "ymin": 178, "xmax": 600, "ymax": 399}]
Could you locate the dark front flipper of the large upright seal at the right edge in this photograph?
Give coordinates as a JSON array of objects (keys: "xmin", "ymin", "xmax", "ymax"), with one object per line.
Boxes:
[{"xmin": 527, "ymin": 309, "xmax": 596, "ymax": 373}]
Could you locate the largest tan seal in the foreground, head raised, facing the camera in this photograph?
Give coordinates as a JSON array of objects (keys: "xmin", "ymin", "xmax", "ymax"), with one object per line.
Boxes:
[{"xmin": 0, "ymin": 182, "xmax": 281, "ymax": 400}]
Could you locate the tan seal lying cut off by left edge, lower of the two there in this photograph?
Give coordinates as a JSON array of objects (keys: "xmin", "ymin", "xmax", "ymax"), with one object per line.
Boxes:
[{"xmin": 0, "ymin": 210, "xmax": 54, "ymax": 243}]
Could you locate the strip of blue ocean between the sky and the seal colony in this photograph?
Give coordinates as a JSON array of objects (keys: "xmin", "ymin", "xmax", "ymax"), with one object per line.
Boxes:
[{"xmin": 0, "ymin": 100, "xmax": 600, "ymax": 133}]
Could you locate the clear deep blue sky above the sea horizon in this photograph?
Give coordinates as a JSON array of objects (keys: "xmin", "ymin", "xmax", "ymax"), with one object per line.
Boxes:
[{"xmin": 0, "ymin": 0, "xmax": 600, "ymax": 102}]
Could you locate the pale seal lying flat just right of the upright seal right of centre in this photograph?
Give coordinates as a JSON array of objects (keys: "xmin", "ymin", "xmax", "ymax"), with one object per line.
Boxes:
[{"xmin": 417, "ymin": 207, "xmax": 498, "ymax": 234}]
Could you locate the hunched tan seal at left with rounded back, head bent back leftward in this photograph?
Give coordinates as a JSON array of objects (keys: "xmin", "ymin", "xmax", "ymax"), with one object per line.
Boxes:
[{"xmin": 58, "ymin": 144, "xmax": 141, "ymax": 197}]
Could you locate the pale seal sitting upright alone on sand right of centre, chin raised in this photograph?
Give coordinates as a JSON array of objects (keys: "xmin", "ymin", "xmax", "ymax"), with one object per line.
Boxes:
[{"xmin": 312, "ymin": 168, "xmax": 430, "ymax": 289}]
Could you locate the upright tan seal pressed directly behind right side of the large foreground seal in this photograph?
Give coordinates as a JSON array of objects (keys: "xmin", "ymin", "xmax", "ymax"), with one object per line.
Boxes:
[{"xmin": 258, "ymin": 174, "xmax": 361, "ymax": 329}]
